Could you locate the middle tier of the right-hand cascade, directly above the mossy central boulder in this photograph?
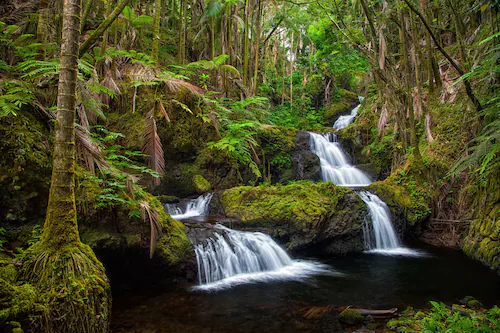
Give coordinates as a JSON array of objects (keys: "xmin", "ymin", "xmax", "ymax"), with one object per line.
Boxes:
[{"xmin": 309, "ymin": 132, "xmax": 371, "ymax": 187}]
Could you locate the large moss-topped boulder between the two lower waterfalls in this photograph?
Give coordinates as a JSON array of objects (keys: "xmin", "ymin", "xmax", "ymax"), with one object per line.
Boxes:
[{"xmin": 221, "ymin": 181, "xmax": 367, "ymax": 253}]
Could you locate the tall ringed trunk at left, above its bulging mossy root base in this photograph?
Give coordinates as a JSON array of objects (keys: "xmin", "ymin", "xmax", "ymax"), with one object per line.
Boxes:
[{"xmin": 42, "ymin": 0, "xmax": 80, "ymax": 248}]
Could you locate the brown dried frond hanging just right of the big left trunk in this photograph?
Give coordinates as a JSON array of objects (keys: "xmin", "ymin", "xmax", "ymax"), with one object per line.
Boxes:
[{"xmin": 75, "ymin": 126, "xmax": 109, "ymax": 174}]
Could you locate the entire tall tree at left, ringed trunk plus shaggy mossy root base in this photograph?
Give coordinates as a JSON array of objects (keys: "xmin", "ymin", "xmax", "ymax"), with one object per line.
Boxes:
[{"xmin": 21, "ymin": 0, "xmax": 110, "ymax": 333}]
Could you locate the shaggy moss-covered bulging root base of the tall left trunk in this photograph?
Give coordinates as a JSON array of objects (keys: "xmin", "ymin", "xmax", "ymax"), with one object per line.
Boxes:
[{"xmin": 21, "ymin": 242, "xmax": 111, "ymax": 333}]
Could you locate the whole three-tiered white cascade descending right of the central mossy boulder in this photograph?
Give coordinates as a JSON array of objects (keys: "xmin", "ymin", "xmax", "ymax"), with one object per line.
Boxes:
[{"xmin": 309, "ymin": 97, "xmax": 421, "ymax": 256}]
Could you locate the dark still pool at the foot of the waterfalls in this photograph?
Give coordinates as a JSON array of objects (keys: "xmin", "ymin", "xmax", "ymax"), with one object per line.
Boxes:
[{"xmin": 112, "ymin": 243, "xmax": 500, "ymax": 333}]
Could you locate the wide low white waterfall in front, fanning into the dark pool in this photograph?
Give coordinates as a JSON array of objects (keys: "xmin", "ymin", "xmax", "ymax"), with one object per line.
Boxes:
[{"xmin": 194, "ymin": 225, "xmax": 340, "ymax": 290}]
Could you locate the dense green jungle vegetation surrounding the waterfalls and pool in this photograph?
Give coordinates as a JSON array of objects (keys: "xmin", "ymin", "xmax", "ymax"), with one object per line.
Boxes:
[{"xmin": 0, "ymin": 0, "xmax": 500, "ymax": 333}]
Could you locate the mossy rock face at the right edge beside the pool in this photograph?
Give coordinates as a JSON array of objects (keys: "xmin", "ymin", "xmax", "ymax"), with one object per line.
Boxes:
[{"xmin": 462, "ymin": 176, "xmax": 500, "ymax": 274}]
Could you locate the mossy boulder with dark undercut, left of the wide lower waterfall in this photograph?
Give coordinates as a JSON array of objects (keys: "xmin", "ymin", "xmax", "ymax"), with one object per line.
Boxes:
[{"xmin": 79, "ymin": 195, "xmax": 195, "ymax": 286}]
